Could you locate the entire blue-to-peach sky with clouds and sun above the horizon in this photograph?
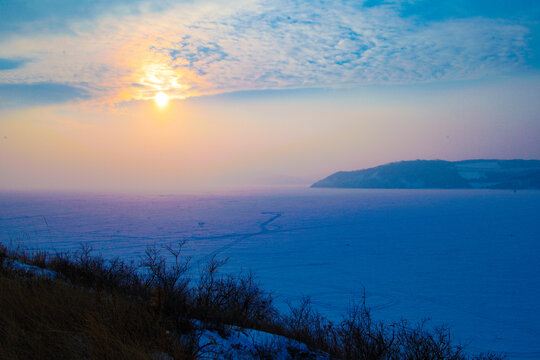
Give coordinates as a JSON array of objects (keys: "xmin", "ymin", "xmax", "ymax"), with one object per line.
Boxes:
[{"xmin": 0, "ymin": 0, "xmax": 540, "ymax": 193}]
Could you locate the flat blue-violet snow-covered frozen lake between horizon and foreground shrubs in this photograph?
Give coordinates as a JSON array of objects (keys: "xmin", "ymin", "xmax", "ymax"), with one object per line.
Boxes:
[{"xmin": 0, "ymin": 189, "xmax": 540, "ymax": 359}]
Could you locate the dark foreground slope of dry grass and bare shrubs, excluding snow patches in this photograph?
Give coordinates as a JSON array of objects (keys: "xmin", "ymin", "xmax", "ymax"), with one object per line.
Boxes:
[{"xmin": 0, "ymin": 243, "xmax": 501, "ymax": 360}]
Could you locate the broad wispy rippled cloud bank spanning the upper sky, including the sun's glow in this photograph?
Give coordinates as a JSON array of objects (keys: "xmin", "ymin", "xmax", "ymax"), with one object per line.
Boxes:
[{"xmin": 0, "ymin": 0, "xmax": 528, "ymax": 106}]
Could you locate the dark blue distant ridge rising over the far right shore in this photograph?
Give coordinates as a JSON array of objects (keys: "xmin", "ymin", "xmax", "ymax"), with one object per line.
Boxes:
[{"xmin": 311, "ymin": 159, "xmax": 540, "ymax": 189}]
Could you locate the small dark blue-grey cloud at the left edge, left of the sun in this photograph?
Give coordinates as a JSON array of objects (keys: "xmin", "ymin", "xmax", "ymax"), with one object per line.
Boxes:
[{"xmin": 0, "ymin": 83, "xmax": 89, "ymax": 108}]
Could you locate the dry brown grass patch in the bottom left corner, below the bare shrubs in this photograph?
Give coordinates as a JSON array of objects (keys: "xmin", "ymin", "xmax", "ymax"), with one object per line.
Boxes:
[{"xmin": 0, "ymin": 271, "xmax": 192, "ymax": 360}]
